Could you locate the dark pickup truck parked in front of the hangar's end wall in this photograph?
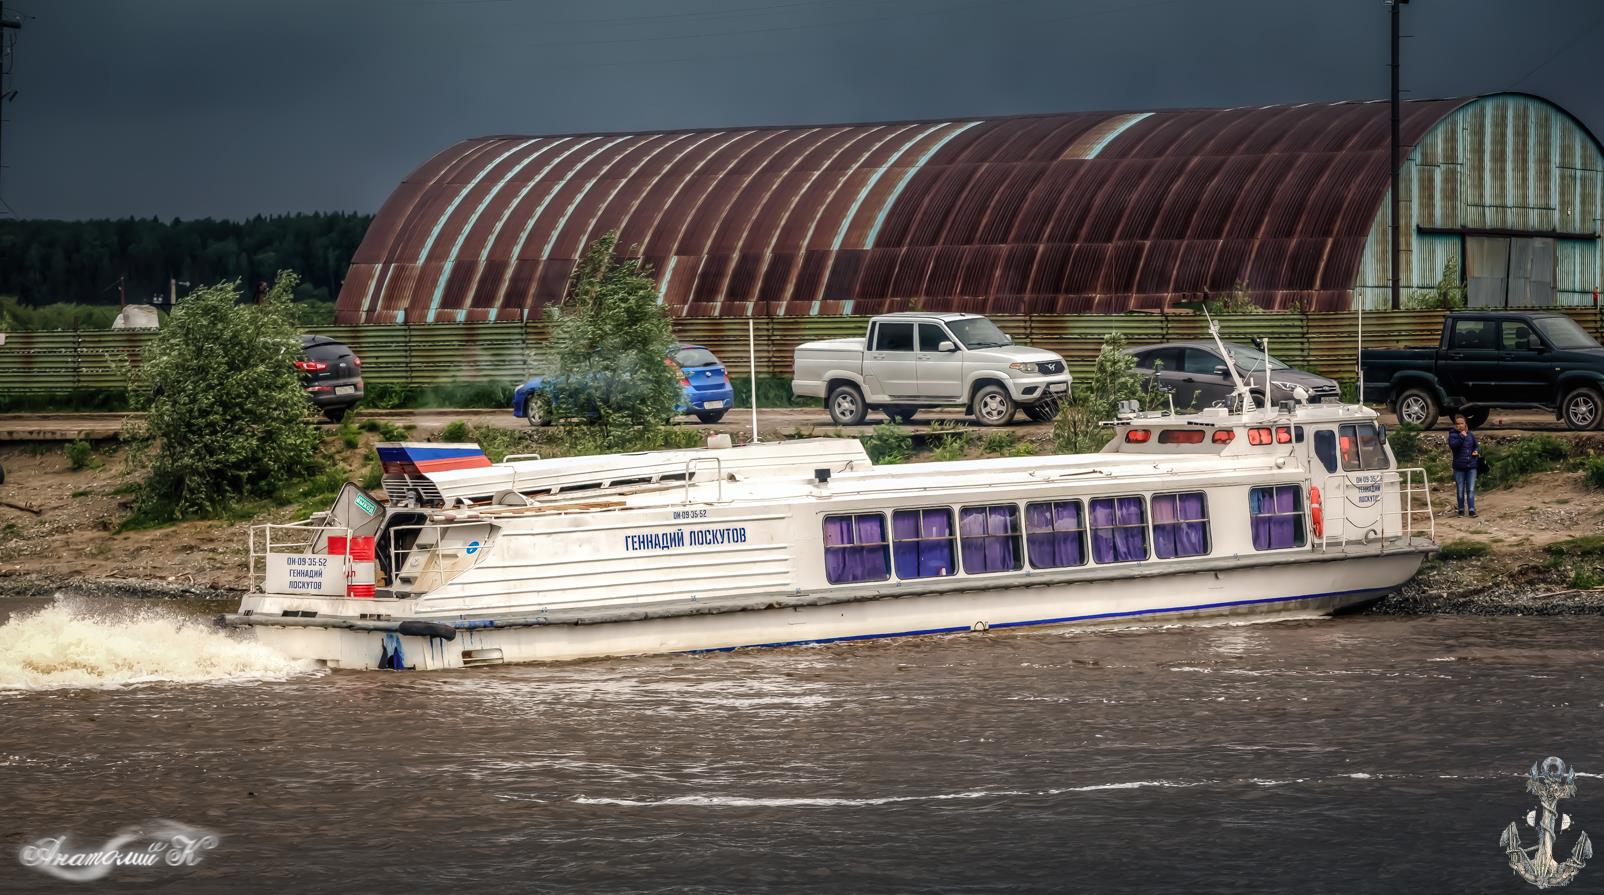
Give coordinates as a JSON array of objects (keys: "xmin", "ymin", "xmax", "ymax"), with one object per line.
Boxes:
[{"xmin": 1359, "ymin": 311, "xmax": 1604, "ymax": 430}]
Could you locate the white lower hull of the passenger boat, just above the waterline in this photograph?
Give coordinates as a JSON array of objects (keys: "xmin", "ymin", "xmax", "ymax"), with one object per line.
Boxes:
[{"xmin": 236, "ymin": 550, "xmax": 1426, "ymax": 670}]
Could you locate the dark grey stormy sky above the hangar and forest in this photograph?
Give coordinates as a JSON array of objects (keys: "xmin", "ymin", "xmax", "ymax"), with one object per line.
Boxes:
[{"xmin": 0, "ymin": 0, "xmax": 1604, "ymax": 218}]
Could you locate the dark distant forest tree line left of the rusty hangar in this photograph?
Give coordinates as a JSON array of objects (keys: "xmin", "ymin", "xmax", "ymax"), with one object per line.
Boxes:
[{"xmin": 0, "ymin": 212, "xmax": 374, "ymax": 308}]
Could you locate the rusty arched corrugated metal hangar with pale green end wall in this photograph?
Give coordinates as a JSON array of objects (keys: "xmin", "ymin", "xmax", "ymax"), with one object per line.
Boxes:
[{"xmin": 337, "ymin": 93, "xmax": 1604, "ymax": 324}]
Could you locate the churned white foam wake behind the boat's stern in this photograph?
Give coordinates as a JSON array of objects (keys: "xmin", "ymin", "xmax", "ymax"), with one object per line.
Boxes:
[{"xmin": 0, "ymin": 601, "xmax": 313, "ymax": 690}]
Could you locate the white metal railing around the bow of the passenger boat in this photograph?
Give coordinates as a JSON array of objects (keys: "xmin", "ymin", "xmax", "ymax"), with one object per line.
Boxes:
[{"xmin": 1310, "ymin": 467, "xmax": 1437, "ymax": 550}]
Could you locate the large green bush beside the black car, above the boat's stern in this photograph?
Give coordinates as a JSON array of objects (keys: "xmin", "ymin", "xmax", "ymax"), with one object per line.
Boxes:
[{"xmin": 127, "ymin": 271, "xmax": 322, "ymax": 524}]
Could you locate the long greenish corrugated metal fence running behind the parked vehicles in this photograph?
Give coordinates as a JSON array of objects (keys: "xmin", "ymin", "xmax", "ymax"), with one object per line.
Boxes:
[{"xmin": 0, "ymin": 308, "xmax": 1601, "ymax": 395}]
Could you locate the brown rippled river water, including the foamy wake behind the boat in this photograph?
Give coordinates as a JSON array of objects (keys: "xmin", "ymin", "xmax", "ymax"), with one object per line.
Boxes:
[{"xmin": 0, "ymin": 598, "xmax": 1604, "ymax": 893}]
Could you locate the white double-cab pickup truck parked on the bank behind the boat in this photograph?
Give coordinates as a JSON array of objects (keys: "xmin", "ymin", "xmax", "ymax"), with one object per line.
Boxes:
[{"xmin": 791, "ymin": 313, "xmax": 1070, "ymax": 425}]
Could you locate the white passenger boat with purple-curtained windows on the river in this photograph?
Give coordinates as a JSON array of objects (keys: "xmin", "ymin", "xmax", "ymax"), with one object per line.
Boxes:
[{"xmin": 223, "ymin": 376, "xmax": 1436, "ymax": 669}]
